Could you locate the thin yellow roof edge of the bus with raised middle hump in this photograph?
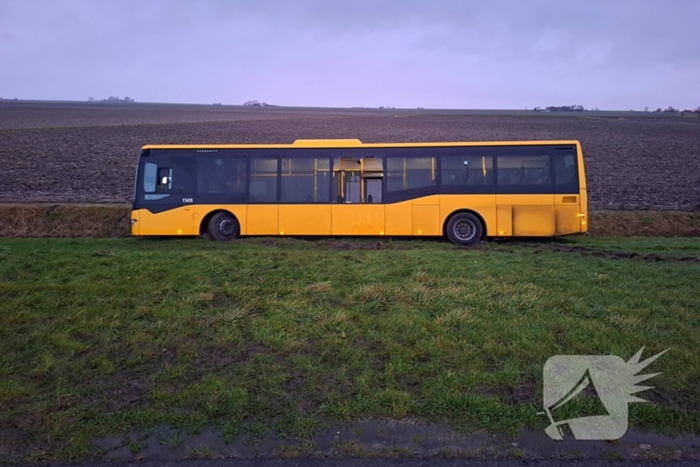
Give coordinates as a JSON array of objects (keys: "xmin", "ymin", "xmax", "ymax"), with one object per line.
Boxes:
[{"xmin": 141, "ymin": 139, "xmax": 580, "ymax": 150}]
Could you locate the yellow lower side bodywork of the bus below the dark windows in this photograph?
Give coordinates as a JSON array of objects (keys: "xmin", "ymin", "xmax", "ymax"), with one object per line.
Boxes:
[{"xmin": 178, "ymin": 195, "xmax": 585, "ymax": 237}]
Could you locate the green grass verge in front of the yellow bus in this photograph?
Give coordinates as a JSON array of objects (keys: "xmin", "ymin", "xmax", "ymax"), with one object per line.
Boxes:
[{"xmin": 0, "ymin": 239, "xmax": 700, "ymax": 460}]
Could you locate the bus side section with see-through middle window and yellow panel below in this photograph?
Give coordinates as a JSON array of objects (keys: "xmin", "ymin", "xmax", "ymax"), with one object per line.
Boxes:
[{"xmin": 331, "ymin": 156, "xmax": 384, "ymax": 235}]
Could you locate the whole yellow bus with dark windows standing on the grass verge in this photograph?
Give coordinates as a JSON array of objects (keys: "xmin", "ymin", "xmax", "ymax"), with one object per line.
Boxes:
[{"xmin": 131, "ymin": 139, "xmax": 588, "ymax": 245}]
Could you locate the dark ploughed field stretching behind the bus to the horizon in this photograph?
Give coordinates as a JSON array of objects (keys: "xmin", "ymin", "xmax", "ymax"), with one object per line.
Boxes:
[{"xmin": 0, "ymin": 103, "xmax": 700, "ymax": 211}]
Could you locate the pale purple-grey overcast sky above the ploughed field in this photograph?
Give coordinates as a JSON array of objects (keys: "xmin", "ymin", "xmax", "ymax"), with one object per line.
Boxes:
[{"xmin": 0, "ymin": 0, "xmax": 700, "ymax": 110}]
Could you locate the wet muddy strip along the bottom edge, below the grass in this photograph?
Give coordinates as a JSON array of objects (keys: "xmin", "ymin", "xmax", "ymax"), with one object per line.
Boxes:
[{"xmin": 94, "ymin": 420, "xmax": 700, "ymax": 463}]
